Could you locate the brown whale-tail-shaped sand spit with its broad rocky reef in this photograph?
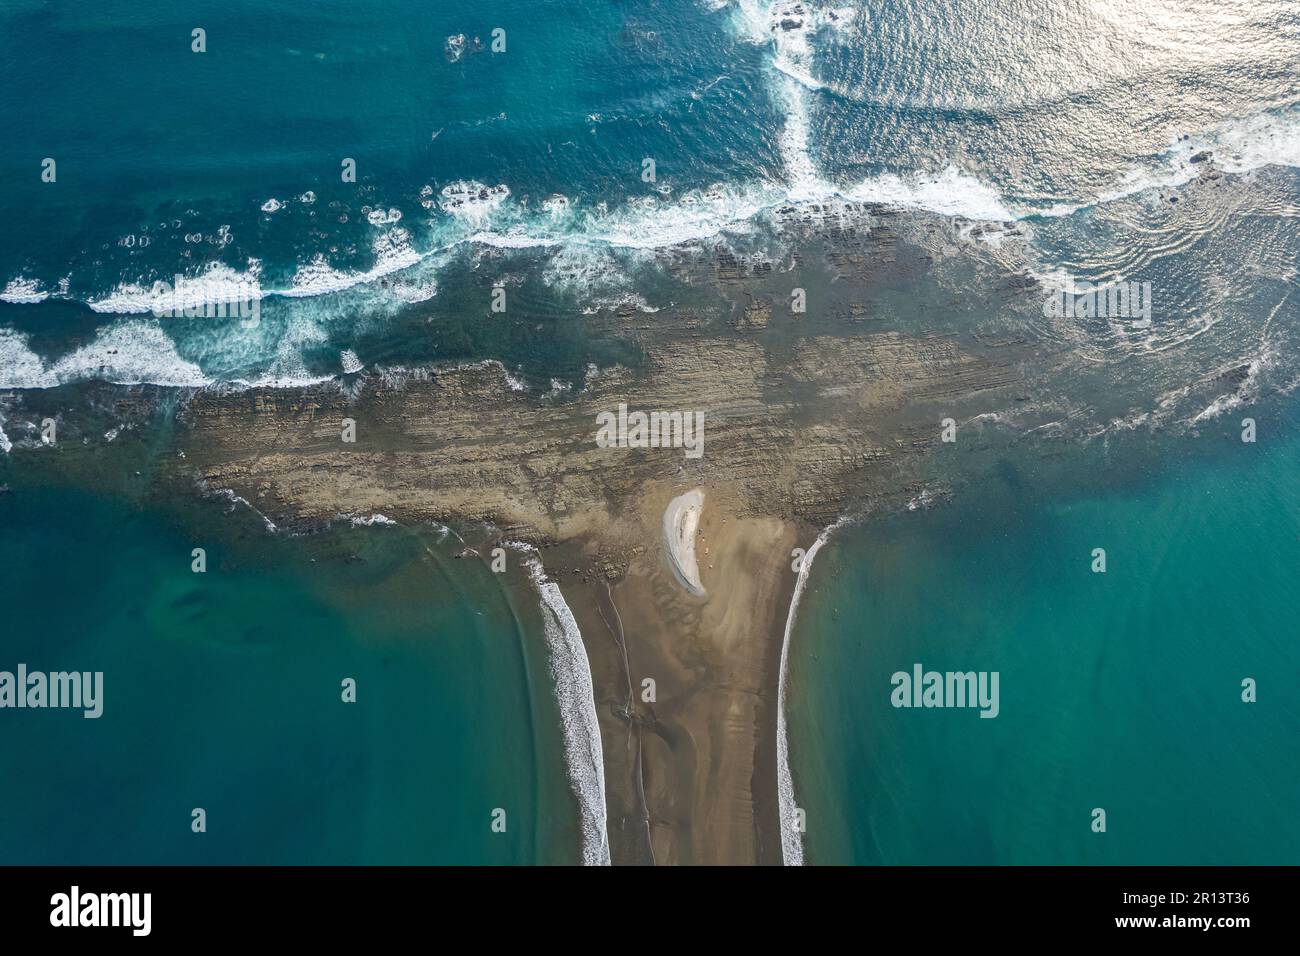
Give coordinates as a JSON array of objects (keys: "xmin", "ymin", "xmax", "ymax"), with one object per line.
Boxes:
[{"xmin": 0, "ymin": 226, "xmax": 1045, "ymax": 865}]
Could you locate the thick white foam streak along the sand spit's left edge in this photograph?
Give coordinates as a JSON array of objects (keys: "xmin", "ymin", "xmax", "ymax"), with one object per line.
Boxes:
[{"xmin": 511, "ymin": 542, "xmax": 610, "ymax": 866}]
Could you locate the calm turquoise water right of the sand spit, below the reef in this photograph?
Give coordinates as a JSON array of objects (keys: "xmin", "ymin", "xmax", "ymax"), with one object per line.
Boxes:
[{"xmin": 789, "ymin": 401, "xmax": 1300, "ymax": 865}]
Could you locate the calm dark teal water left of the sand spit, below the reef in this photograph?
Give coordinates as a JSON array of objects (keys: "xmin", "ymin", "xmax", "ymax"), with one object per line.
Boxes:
[{"xmin": 0, "ymin": 485, "xmax": 579, "ymax": 864}]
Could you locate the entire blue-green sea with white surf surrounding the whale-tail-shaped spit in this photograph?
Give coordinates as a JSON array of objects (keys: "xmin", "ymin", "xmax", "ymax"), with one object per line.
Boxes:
[{"xmin": 0, "ymin": 0, "xmax": 1300, "ymax": 862}]
